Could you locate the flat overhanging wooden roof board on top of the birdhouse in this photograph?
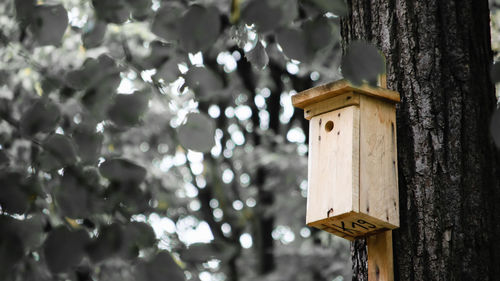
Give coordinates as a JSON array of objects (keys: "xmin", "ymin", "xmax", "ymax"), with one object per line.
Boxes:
[{"xmin": 292, "ymin": 80, "xmax": 401, "ymax": 109}]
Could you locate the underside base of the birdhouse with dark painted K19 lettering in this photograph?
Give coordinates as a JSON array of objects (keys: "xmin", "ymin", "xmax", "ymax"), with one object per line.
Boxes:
[{"xmin": 307, "ymin": 212, "xmax": 397, "ymax": 241}]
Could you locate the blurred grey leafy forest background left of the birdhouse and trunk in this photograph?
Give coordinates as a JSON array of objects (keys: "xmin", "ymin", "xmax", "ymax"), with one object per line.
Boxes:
[{"xmin": 0, "ymin": 0, "xmax": 500, "ymax": 281}]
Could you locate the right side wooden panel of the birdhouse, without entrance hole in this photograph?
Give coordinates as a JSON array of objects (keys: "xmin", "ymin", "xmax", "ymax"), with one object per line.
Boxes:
[{"xmin": 359, "ymin": 95, "xmax": 399, "ymax": 228}]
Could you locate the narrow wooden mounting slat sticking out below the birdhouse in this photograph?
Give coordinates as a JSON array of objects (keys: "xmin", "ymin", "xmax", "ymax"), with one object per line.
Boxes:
[{"xmin": 366, "ymin": 231, "xmax": 394, "ymax": 281}]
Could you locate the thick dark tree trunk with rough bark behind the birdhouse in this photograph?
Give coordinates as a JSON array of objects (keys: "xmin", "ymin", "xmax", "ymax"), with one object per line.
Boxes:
[{"xmin": 342, "ymin": 0, "xmax": 500, "ymax": 281}]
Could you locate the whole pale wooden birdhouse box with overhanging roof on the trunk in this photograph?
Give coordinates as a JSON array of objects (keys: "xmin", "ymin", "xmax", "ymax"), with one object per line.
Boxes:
[{"xmin": 292, "ymin": 80, "xmax": 400, "ymax": 240}]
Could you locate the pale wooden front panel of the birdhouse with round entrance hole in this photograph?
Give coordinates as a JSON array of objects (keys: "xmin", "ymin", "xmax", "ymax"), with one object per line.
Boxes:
[{"xmin": 306, "ymin": 106, "xmax": 359, "ymax": 224}]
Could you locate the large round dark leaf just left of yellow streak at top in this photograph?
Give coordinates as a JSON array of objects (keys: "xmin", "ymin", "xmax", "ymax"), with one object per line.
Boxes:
[{"xmin": 176, "ymin": 5, "xmax": 221, "ymax": 53}]
